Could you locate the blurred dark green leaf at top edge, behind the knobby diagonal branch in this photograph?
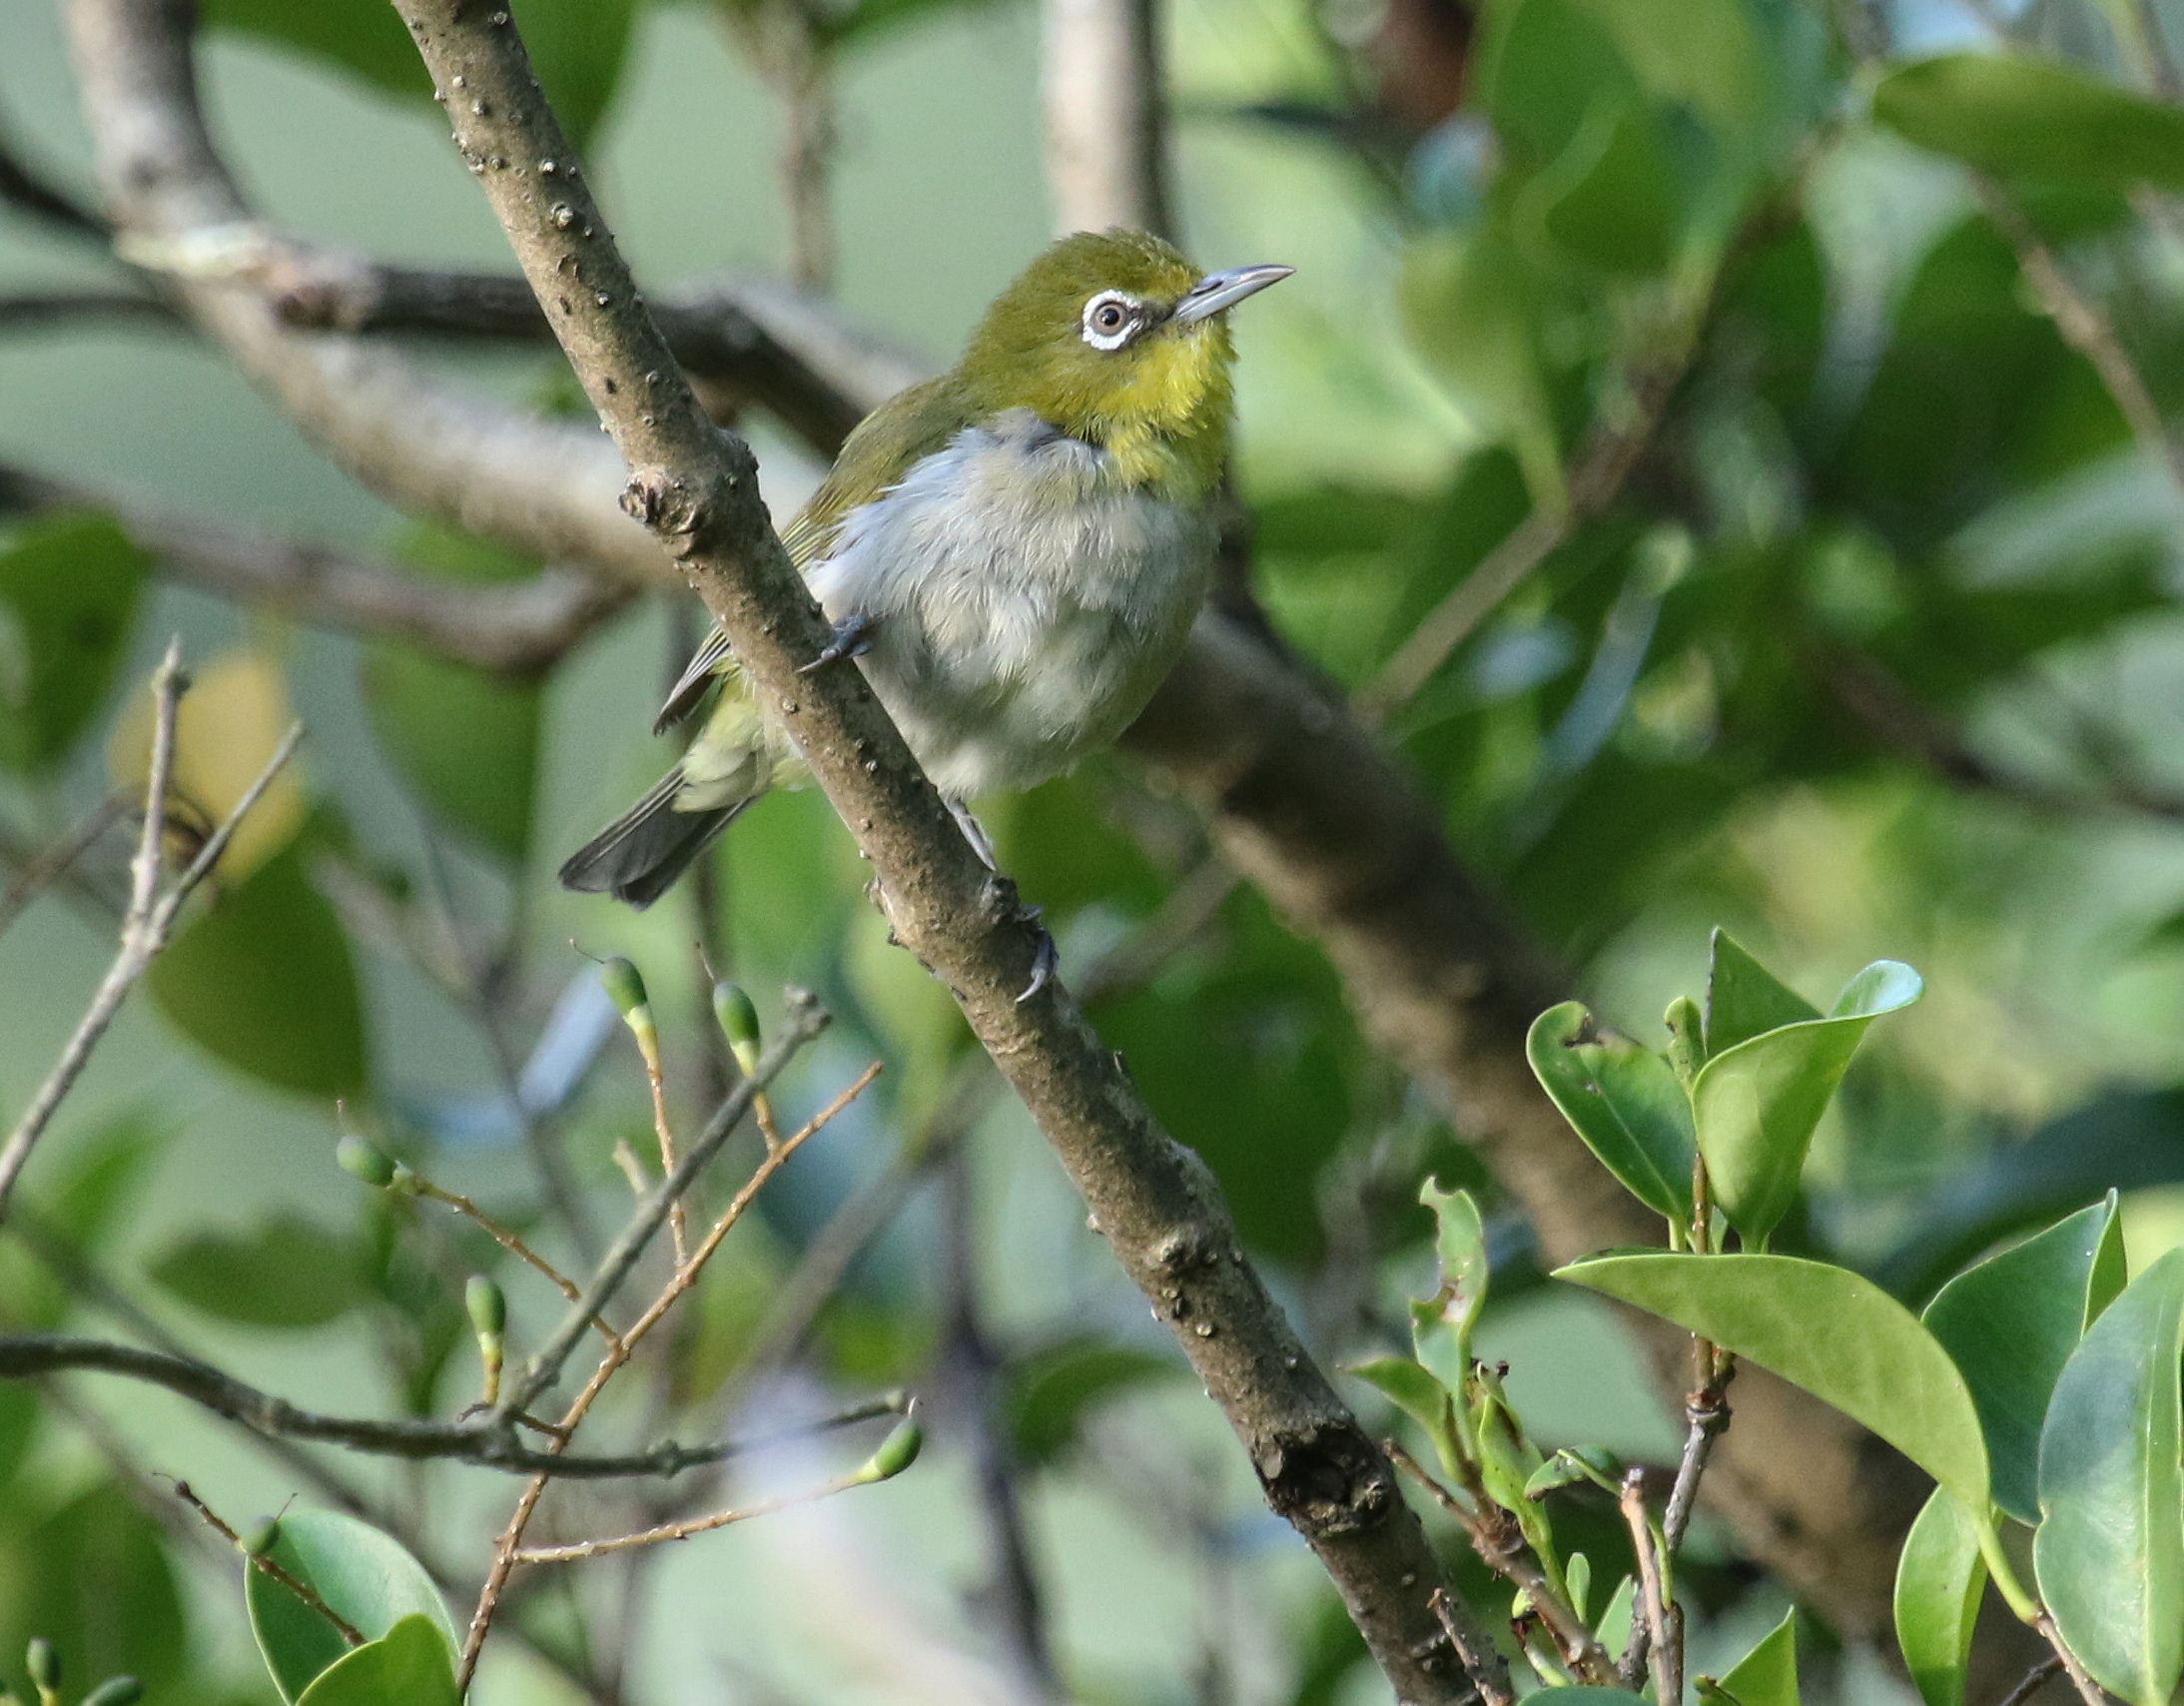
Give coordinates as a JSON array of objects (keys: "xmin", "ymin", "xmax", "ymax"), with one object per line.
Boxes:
[{"xmin": 203, "ymin": 0, "xmax": 635, "ymax": 147}]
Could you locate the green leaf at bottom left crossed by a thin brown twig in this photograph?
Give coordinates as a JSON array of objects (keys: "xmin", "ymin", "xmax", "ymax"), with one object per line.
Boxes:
[{"xmin": 243, "ymin": 1509, "xmax": 460, "ymax": 1706}]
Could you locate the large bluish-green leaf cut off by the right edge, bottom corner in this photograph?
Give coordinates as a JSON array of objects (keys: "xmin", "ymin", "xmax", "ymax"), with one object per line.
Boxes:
[{"xmin": 2033, "ymin": 1250, "xmax": 2184, "ymax": 1706}]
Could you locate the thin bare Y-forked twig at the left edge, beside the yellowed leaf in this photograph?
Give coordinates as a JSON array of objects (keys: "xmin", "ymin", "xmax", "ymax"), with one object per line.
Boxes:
[{"xmin": 0, "ymin": 638, "xmax": 304, "ymax": 1221}]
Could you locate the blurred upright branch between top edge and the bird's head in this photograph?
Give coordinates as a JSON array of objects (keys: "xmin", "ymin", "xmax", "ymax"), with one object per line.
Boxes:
[{"xmin": 1040, "ymin": 0, "xmax": 1175, "ymax": 238}]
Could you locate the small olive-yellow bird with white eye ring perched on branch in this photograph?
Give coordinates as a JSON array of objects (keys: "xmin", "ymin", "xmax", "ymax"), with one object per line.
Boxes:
[{"xmin": 561, "ymin": 230, "xmax": 1291, "ymax": 907}]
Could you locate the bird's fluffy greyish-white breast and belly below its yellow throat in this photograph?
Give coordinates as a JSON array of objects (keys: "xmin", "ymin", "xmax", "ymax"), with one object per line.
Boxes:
[{"xmin": 808, "ymin": 409, "xmax": 1214, "ymax": 799}]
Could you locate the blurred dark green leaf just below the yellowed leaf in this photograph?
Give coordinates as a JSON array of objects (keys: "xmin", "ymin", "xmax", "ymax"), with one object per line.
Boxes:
[{"xmin": 144, "ymin": 845, "xmax": 366, "ymax": 1097}]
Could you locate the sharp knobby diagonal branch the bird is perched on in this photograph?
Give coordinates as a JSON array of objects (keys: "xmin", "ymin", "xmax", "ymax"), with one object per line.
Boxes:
[{"xmin": 394, "ymin": 0, "xmax": 1463, "ymax": 1702}]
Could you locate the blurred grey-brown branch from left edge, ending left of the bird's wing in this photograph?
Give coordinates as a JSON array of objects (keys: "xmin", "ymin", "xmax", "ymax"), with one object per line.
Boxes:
[{"xmin": 0, "ymin": 465, "xmax": 635, "ymax": 675}]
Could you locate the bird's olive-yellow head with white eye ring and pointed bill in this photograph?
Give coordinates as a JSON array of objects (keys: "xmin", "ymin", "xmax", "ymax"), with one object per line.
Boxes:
[{"xmin": 959, "ymin": 230, "xmax": 1291, "ymax": 493}]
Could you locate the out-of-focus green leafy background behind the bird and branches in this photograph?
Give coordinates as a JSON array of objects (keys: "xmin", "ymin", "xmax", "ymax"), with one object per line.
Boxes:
[{"xmin": 0, "ymin": 0, "xmax": 2184, "ymax": 1706}]
